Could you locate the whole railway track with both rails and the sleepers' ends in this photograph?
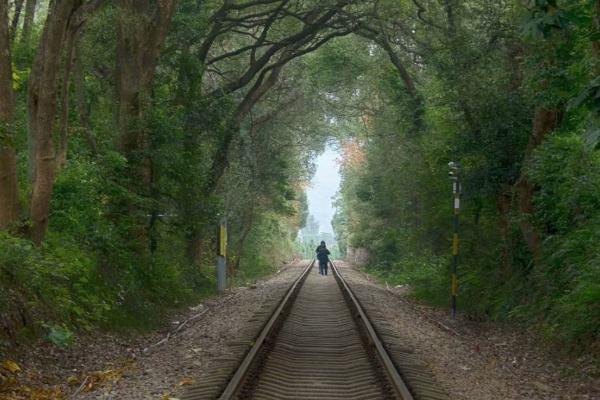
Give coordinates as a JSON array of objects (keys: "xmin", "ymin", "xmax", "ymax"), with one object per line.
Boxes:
[{"xmin": 182, "ymin": 261, "xmax": 447, "ymax": 400}]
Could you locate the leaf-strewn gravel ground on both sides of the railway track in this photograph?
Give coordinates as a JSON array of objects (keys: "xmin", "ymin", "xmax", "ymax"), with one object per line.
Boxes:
[{"xmin": 0, "ymin": 263, "xmax": 600, "ymax": 400}]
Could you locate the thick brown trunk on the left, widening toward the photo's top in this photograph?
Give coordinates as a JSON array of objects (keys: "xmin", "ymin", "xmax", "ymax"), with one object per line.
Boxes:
[{"xmin": 117, "ymin": 0, "xmax": 176, "ymax": 252}]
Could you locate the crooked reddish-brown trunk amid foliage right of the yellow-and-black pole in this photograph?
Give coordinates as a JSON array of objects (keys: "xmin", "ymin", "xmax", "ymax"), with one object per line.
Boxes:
[{"xmin": 515, "ymin": 107, "xmax": 562, "ymax": 262}]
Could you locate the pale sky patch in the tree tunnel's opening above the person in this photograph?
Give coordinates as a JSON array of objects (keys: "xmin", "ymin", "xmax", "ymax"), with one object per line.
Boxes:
[{"xmin": 306, "ymin": 146, "xmax": 341, "ymax": 233}]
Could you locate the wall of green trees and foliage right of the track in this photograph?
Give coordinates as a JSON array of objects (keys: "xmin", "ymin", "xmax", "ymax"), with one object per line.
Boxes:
[{"xmin": 334, "ymin": 0, "xmax": 600, "ymax": 351}]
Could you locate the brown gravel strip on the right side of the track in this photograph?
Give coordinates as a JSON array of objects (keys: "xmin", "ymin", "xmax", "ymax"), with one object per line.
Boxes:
[{"xmin": 336, "ymin": 262, "xmax": 600, "ymax": 400}]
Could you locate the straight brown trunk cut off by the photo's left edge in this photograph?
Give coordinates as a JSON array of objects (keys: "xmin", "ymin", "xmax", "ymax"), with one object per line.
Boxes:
[{"xmin": 0, "ymin": 0, "xmax": 19, "ymax": 230}]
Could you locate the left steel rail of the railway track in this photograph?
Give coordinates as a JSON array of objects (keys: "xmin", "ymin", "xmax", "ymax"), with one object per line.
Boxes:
[{"xmin": 219, "ymin": 259, "xmax": 315, "ymax": 400}]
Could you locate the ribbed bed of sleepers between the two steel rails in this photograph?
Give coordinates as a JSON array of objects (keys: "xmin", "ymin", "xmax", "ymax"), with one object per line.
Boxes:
[{"xmin": 254, "ymin": 268, "xmax": 390, "ymax": 399}]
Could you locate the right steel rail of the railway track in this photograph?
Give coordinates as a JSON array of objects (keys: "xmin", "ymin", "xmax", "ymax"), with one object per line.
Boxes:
[{"xmin": 331, "ymin": 261, "xmax": 414, "ymax": 400}]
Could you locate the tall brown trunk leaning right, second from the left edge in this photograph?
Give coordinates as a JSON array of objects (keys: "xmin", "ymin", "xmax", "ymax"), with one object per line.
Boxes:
[{"xmin": 28, "ymin": 0, "xmax": 82, "ymax": 244}]
